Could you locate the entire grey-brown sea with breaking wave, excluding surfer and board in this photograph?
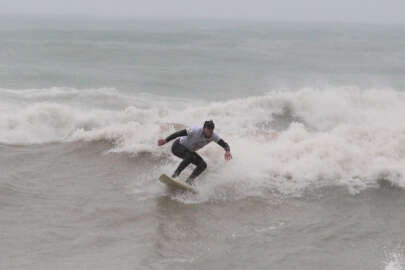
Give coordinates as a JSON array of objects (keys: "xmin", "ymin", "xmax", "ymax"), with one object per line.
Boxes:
[{"xmin": 0, "ymin": 15, "xmax": 405, "ymax": 270}]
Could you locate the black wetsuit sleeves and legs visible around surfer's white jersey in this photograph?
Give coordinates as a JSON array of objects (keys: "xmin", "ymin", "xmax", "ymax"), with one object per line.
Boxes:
[{"xmin": 166, "ymin": 129, "xmax": 230, "ymax": 184}]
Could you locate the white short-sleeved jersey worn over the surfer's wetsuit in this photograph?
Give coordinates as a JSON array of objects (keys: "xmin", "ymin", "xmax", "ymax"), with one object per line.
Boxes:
[{"xmin": 180, "ymin": 126, "xmax": 221, "ymax": 151}]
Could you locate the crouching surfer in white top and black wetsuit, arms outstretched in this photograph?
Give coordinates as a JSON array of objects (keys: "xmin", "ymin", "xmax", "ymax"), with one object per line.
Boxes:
[{"xmin": 158, "ymin": 120, "xmax": 232, "ymax": 185}]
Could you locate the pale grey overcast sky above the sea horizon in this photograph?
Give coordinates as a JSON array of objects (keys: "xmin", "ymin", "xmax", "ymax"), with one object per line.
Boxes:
[{"xmin": 0, "ymin": 0, "xmax": 405, "ymax": 24}]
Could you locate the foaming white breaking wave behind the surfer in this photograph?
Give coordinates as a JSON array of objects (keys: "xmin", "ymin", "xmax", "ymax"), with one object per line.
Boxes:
[{"xmin": 0, "ymin": 87, "xmax": 405, "ymax": 193}]
